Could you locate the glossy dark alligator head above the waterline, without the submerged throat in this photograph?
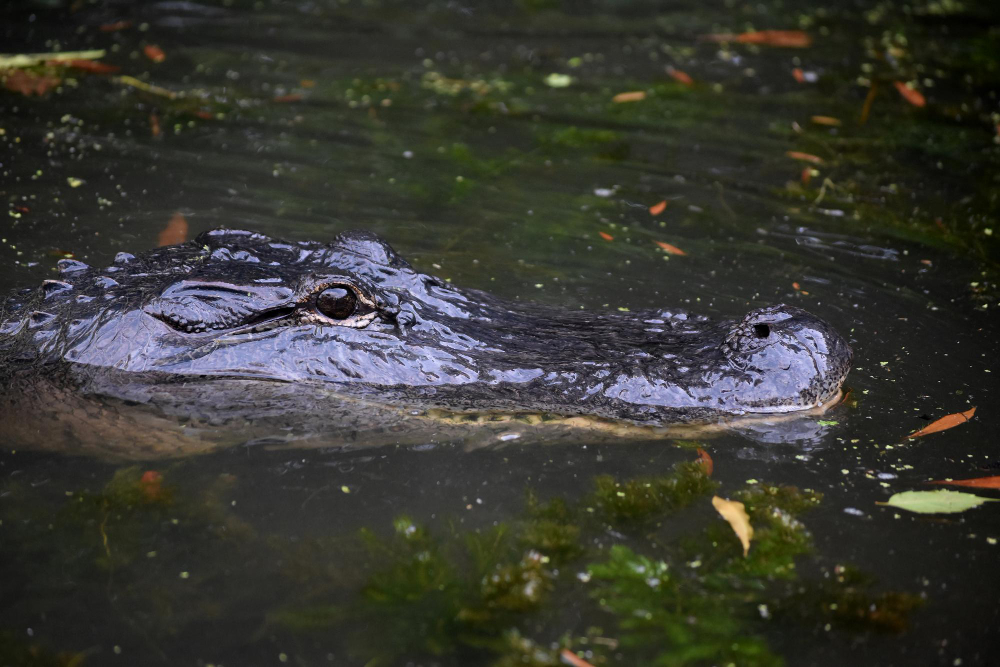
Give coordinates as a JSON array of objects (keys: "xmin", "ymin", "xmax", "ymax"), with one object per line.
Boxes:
[{"xmin": 0, "ymin": 230, "xmax": 851, "ymax": 423}]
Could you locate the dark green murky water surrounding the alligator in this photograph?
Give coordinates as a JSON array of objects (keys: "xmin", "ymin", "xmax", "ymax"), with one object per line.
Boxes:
[{"xmin": 0, "ymin": 0, "xmax": 1000, "ymax": 665}]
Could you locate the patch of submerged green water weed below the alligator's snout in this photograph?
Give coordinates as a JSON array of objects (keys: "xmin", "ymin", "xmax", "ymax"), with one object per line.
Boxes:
[{"xmin": 270, "ymin": 470, "xmax": 912, "ymax": 666}]
